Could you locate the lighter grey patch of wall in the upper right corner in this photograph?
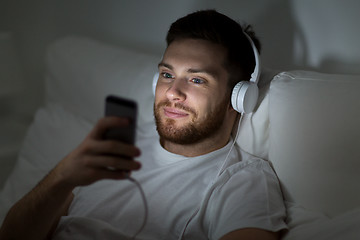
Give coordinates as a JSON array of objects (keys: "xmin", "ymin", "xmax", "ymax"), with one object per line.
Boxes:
[{"xmin": 293, "ymin": 0, "xmax": 360, "ymax": 74}]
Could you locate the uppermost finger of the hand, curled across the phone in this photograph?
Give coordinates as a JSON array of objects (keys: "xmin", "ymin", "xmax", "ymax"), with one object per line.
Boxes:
[{"xmin": 88, "ymin": 116, "xmax": 130, "ymax": 139}]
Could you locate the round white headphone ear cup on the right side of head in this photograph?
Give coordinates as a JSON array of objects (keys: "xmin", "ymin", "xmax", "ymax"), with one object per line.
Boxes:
[{"xmin": 231, "ymin": 81, "xmax": 259, "ymax": 113}]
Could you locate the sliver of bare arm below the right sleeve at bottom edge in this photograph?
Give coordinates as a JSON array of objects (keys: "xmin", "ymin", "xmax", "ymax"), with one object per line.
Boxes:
[{"xmin": 220, "ymin": 228, "xmax": 280, "ymax": 240}]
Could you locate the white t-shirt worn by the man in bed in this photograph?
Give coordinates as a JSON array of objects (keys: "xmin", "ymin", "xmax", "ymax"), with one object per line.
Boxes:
[{"xmin": 54, "ymin": 128, "xmax": 286, "ymax": 240}]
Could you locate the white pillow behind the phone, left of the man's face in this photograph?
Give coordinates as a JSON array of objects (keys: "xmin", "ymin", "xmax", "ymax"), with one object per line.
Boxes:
[{"xmin": 46, "ymin": 36, "xmax": 160, "ymax": 125}]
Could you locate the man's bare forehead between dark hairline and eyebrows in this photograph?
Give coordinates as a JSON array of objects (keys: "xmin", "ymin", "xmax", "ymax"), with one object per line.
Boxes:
[{"xmin": 162, "ymin": 39, "xmax": 226, "ymax": 78}]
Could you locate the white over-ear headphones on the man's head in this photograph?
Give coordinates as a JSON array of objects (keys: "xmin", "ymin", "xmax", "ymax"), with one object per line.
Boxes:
[{"xmin": 152, "ymin": 32, "xmax": 261, "ymax": 113}]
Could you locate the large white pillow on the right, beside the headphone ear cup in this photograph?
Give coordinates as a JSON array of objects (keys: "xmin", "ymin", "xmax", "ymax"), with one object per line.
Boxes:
[{"xmin": 269, "ymin": 71, "xmax": 360, "ymax": 216}]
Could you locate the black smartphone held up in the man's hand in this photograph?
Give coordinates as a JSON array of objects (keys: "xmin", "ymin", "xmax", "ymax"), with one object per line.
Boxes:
[{"xmin": 104, "ymin": 95, "xmax": 137, "ymax": 144}]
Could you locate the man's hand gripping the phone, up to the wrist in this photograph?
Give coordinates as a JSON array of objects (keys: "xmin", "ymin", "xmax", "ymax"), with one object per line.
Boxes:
[{"xmin": 53, "ymin": 117, "xmax": 141, "ymax": 187}]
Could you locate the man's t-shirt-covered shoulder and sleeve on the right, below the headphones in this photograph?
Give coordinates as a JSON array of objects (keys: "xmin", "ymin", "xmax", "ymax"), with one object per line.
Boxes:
[{"xmin": 207, "ymin": 152, "xmax": 286, "ymax": 239}]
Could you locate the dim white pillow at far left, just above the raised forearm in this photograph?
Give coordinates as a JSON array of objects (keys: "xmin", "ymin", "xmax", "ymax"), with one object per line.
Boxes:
[{"xmin": 0, "ymin": 104, "xmax": 92, "ymax": 224}]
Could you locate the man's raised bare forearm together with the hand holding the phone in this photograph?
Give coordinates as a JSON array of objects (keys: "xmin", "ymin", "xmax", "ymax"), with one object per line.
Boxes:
[{"xmin": 0, "ymin": 117, "xmax": 140, "ymax": 239}]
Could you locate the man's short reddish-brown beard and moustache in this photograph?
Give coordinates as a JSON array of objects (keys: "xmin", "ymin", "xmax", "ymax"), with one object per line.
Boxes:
[{"xmin": 154, "ymin": 98, "xmax": 228, "ymax": 145}]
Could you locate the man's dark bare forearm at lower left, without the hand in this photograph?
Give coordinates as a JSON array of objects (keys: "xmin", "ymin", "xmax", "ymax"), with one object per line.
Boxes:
[{"xmin": 0, "ymin": 171, "xmax": 73, "ymax": 239}]
